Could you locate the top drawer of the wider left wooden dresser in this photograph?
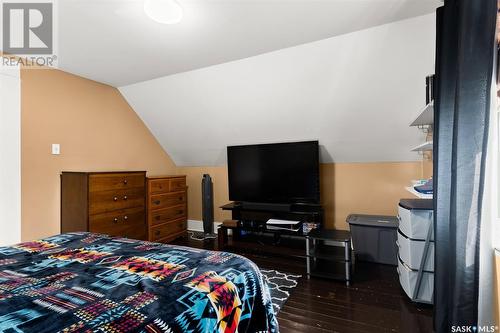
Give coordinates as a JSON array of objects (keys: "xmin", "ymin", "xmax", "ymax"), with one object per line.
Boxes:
[{"xmin": 89, "ymin": 173, "xmax": 146, "ymax": 192}]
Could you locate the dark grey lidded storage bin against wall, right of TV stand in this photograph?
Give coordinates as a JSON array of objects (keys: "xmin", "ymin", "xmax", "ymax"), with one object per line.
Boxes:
[{"xmin": 347, "ymin": 214, "xmax": 398, "ymax": 266}]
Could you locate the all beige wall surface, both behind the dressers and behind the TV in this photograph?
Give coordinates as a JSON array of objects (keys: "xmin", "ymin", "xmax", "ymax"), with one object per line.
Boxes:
[{"xmin": 21, "ymin": 69, "xmax": 431, "ymax": 240}]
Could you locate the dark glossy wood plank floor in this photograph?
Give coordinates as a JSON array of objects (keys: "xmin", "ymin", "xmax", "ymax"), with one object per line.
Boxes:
[{"xmin": 171, "ymin": 239, "xmax": 432, "ymax": 333}]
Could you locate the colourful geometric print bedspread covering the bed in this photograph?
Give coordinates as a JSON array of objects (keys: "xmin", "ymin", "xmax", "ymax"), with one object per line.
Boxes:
[{"xmin": 0, "ymin": 232, "xmax": 278, "ymax": 333}]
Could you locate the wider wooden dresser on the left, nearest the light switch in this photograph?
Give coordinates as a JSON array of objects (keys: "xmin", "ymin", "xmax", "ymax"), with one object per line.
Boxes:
[{"xmin": 61, "ymin": 171, "xmax": 147, "ymax": 240}]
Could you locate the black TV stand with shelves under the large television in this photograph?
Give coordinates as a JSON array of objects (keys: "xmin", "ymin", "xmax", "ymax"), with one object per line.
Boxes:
[{"xmin": 219, "ymin": 202, "xmax": 323, "ymax": 259}]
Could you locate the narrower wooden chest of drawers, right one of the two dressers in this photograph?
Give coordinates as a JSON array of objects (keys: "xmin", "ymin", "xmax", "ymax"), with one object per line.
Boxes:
[{"xmin": 146, "ymin": 176, "xmax": 187, "ymax": 242}]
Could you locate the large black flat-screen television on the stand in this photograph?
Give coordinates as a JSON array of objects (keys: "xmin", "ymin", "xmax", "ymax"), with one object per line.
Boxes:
[{"xmin": 227, "ymin": 141, "xmax": 319, "ymax": 203}]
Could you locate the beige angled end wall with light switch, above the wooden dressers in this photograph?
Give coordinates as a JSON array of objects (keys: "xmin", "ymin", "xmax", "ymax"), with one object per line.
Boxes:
[{"xmin": 21, "ymin": 69, "xmax": 176, "ymax": 240}]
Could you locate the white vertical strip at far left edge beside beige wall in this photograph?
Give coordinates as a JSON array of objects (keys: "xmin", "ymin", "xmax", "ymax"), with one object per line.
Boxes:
[{"xmin": 0, "ymin": 58, "xmax": 21, "ymax": 246}]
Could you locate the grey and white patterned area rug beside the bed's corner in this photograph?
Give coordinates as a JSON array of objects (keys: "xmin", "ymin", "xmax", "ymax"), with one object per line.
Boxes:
[{"xmin": 260, "ymin": 269, "xmax": 302, "ymax": 314}]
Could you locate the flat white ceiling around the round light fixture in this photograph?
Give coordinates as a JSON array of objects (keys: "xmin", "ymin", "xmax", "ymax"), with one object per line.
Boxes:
[{"xmin": 58, "ymin": 0, "xmax": 439, "ymax": 87}]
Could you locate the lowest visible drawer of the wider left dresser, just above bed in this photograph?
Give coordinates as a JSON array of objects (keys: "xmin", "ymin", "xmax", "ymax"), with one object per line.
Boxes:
[{"xmin": 89, "ymin": 207, "xmax": 146, "ymax": 239}]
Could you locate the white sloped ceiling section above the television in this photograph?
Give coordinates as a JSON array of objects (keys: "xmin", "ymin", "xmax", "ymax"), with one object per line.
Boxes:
[{"xmin": 120, "ymin": 14, "xmax": 435, "ymax": 166}]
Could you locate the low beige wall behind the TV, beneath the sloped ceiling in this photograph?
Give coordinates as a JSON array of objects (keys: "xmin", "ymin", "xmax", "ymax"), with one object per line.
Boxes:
[{"xmin": 178, "ymin": 162, "xmax": 423, "ymax": 229}]
